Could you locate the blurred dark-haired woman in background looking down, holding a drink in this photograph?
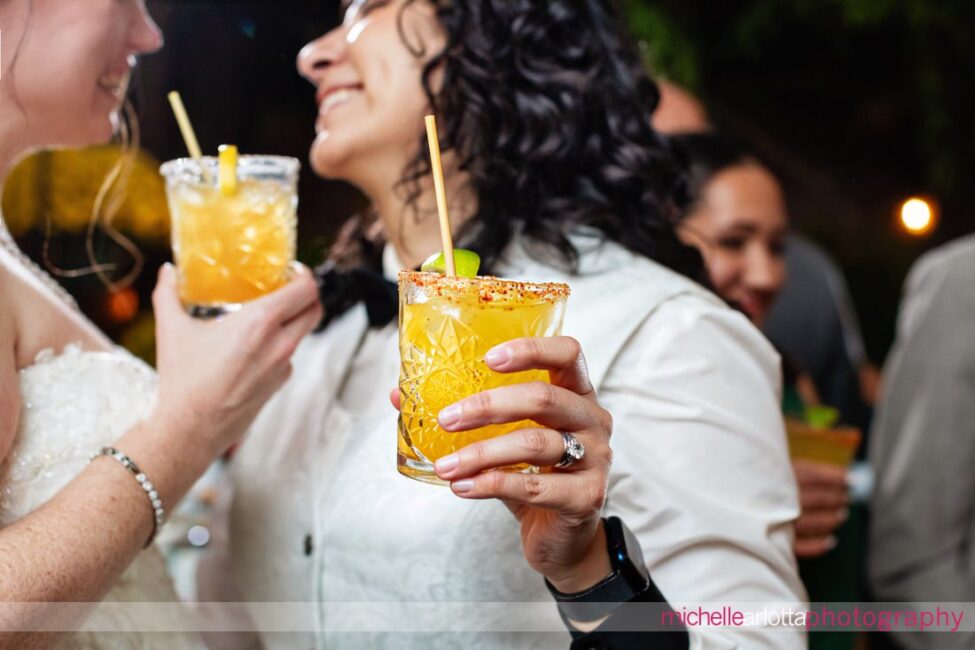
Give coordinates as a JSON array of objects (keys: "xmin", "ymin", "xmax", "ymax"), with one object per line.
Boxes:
[{"xmin": 672, "ymin": 134, "xmax": 857, "ymax": 648}]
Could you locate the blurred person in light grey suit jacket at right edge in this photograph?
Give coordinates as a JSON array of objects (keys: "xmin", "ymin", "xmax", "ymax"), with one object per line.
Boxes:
[{"xmin": 869, "ymin": 235, "xmax": 975, "ymax": 650}]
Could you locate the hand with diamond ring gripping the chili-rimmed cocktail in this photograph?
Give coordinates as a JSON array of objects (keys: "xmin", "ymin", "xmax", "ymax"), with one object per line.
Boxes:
[{"xmin": 393, "ymin": 336, "xmax": 613, "ymax": 593}]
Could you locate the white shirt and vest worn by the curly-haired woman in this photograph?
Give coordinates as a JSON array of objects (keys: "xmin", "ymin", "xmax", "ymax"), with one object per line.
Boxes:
[{"xmin": 202, "ymin": 230, "xmax": 805, "ymax": 650}]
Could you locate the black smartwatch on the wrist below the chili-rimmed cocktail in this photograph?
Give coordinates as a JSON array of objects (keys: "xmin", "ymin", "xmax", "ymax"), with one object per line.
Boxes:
[{"xmin": 545, "ymin": 517, "xmax": 650, "ymax": 627}]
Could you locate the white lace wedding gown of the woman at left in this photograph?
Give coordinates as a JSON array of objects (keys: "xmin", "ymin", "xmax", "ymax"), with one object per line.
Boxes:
[{"xmin": 0, "ymin": 239, "xmax": 203, "ymax": 650}]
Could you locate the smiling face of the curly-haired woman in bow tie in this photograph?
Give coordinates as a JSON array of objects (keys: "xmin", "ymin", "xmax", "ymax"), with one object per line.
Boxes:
[{"xmin": 298, "ymin": 0, "xmax": 445, "ymax": 185}]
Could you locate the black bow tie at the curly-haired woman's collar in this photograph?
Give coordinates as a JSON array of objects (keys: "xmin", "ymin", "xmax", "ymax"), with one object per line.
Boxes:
[{"xmin": 315, "ymin": 262, "xmax": 399, "ymax": 332}]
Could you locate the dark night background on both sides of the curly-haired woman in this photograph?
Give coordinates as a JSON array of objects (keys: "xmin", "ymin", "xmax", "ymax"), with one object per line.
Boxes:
[{"xmin": 7, "ymin": 0, "xmax": 975, "ymax": 362}]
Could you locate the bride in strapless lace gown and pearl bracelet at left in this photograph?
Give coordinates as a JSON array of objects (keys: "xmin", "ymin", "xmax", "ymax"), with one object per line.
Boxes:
[{"xmin": 0, "ymin": 0, "xmax": 321, "ymax": 649}]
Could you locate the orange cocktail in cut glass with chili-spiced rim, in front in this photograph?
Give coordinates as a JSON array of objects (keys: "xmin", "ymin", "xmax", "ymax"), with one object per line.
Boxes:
[{"xmin": 397, "ymin": 271, "xmax": 569, "ymax": 484}]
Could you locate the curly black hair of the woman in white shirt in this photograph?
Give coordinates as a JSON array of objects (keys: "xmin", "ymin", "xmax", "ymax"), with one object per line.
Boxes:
[{"xmin": 339, "ymin": 0, "xmax": 708, "ymax": 285}]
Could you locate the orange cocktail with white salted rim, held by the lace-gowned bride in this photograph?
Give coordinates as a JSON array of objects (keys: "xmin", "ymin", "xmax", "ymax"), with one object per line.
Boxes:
[{"xmin": 161, "ymin": 156, "xmax": 299, "ymax": 317}]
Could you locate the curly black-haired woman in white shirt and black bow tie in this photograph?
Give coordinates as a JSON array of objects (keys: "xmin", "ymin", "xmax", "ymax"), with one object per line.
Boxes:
[{"xmin": 203, "ymin": 0, "xmax": 804, "ymax": 648}]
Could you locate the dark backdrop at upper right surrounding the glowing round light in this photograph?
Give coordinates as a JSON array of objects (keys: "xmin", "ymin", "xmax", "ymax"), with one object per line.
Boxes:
[{"xmin": 620, "ymin": 0, "xmax": 975, "ymax": 361}]
